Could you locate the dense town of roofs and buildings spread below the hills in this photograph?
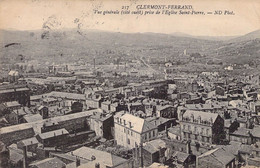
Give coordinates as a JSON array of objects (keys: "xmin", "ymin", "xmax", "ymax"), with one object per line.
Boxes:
[{"xmin": 0, "ymin": 43, "xmax": 260, "ymax": 168}]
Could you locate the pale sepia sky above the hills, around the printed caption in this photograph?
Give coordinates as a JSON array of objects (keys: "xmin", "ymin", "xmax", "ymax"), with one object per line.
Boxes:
[{"xmin": 0, "ymin": 0, "xmax": 260, "ymax": 36}]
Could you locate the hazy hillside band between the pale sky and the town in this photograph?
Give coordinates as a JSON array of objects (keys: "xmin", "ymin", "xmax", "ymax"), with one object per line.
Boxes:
[{"xmin": 0, "ymin": 29, "xmax": 260, "ymax": 65}]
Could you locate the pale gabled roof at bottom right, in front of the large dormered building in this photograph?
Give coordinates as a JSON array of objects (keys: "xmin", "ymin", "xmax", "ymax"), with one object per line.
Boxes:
[{"xmin": 198, "ymin": 148, "xmax": 235, "ymax": 165}]
